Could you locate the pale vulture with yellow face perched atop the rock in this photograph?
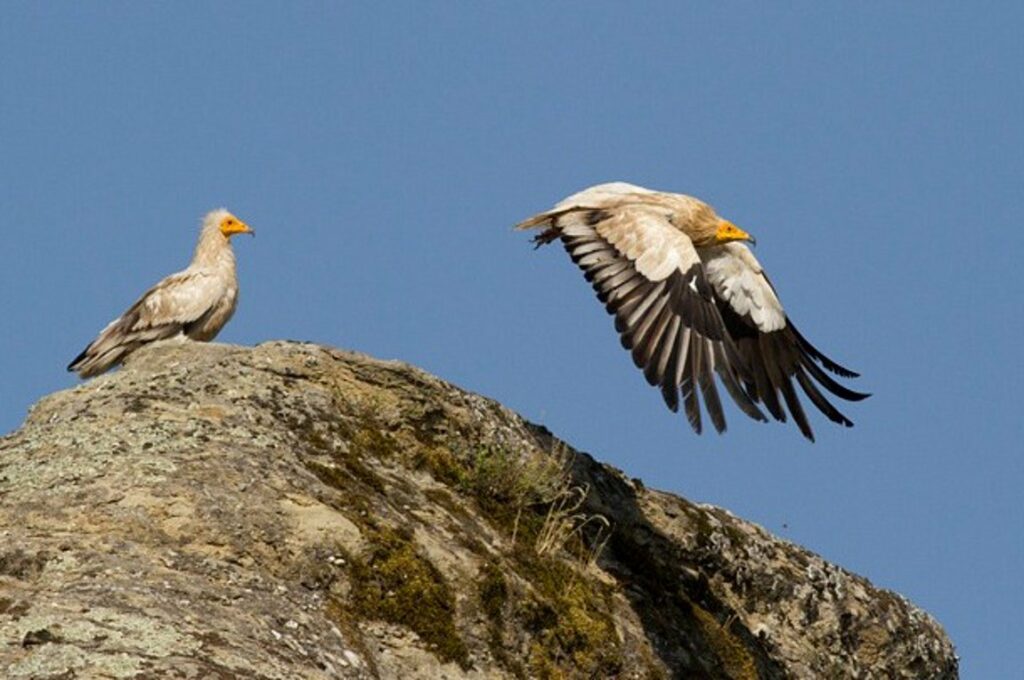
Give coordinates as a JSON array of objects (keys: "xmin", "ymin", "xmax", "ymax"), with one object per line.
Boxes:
[{"xmin": 68, "ymin": 209, "xmax": 254, "ymax": 378}]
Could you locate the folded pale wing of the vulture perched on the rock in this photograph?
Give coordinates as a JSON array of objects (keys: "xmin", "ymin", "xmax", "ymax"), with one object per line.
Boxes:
[{"xmin": 68, "ymin": 269, "xmax": 222, "ymax": 378}]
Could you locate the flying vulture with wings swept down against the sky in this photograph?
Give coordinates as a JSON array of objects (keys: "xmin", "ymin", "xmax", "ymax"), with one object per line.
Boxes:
[{"xmin": 516, "ymin": 182, "xmax": 868, "ymax": 441}]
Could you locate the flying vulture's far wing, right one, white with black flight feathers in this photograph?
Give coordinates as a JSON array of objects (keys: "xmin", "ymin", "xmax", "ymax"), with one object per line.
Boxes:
[{"xmin": 699, "ymin": 243, "xmax": 868, "ymax": 441}]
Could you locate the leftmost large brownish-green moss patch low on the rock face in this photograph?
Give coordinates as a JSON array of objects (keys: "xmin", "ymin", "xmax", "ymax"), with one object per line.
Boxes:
[{"xmin": 350, "ymin": 528, "xmax": 469, "ymax": 668}]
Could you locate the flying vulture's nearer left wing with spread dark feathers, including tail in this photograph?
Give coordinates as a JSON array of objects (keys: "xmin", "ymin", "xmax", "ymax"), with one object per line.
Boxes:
[{"xmin": 518, "ymin": 204, "xmax": 767, "ymax": 432}]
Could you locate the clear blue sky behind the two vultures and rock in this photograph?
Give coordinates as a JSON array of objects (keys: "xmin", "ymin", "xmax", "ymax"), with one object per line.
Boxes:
[{"xmin": 0, "ymin": 2, "xmax": 1024, "ymax": 678}]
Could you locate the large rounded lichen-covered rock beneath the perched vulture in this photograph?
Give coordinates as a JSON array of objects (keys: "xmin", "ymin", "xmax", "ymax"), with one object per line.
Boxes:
[{"xmin": 0, "ymin": 342, "xmax": 957, "ymax": 679}]
